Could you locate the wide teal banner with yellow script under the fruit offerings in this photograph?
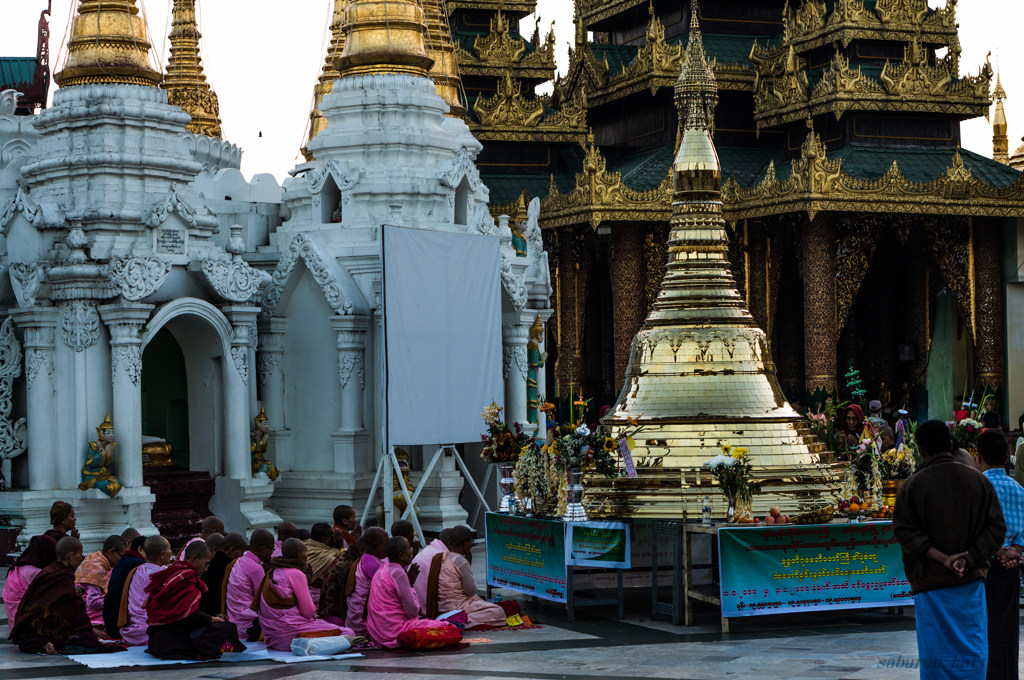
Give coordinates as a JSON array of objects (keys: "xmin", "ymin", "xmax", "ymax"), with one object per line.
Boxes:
[{"xmin": 718, "ymin": 522, "xmax": 913, "ymax": 617}]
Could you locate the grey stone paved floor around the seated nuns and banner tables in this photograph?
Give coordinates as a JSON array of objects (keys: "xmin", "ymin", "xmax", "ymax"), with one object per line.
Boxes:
[{"xmin": 0, "ymin": 555, "xmax": 1024, "ymax": 680}]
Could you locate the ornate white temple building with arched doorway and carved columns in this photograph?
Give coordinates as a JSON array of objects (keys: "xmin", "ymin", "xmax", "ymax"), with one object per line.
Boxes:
[{"xmin": 0, "ymin": 1, "xmax": 551, "ymax": 545}]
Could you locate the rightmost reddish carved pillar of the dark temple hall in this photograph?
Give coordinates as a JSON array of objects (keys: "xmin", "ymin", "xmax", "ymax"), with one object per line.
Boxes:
[{"xmin": 973, "ymin": 218, "xmax": 1005, "ymax": 393}]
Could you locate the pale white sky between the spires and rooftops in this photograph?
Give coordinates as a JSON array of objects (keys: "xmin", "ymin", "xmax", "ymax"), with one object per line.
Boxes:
[{"xmin": 0, "ymin": 0, "xmax": 1011, "ymax": 180}]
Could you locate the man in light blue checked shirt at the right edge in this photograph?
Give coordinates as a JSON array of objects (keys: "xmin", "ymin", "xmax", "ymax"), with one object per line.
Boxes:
[{"xmin": 978, "ymin": 429, "xmax": 1024, "ymax": 680}]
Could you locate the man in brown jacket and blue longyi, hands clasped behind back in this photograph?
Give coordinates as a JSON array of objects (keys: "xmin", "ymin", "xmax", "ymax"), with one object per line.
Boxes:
[{"xmin": 893, "ymin": 420, "xmax": 1006, "ymax": 680}]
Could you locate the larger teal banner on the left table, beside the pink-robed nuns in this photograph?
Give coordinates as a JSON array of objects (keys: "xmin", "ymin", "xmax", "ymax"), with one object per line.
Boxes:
[{"xmin": 486, "ymin": 512, "xmax": 565, "ymax": 602}]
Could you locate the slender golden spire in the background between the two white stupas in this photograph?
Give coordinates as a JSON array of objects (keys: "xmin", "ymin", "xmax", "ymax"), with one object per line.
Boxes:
[{"xmin": 162, "ymin": 0, "xmax": 223, "ymax": 139}]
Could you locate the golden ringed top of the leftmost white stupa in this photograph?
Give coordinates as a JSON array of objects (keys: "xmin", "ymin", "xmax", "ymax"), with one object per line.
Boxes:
[{"xmin": 53, "ymin": 0, "xmax": 163, "ymax": 87}]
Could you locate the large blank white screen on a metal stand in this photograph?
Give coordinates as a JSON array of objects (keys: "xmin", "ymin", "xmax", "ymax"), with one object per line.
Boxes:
[{"xmin": 382, "ymin": 226, "xmax": 505, "ymax": 445}]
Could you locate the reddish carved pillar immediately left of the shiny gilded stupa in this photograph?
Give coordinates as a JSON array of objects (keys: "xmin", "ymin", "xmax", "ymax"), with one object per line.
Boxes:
[{"xmin": 608, "ymin": 224, "xmax": 647, "ymax": 392}]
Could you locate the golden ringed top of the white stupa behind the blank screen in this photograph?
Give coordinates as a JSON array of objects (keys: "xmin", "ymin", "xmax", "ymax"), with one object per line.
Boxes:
[{"xmin": 334, "ymin": 0, "xmax": 434, "ymax": 78}]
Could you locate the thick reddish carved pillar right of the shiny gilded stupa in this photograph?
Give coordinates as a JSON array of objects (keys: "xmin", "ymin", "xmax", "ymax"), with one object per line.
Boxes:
[{"xmin": 803, "ymin": 213, "xmax": 839, "ymax": 406}]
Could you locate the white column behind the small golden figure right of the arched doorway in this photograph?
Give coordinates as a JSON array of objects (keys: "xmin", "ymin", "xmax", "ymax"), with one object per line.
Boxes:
[{"xmin": 256, "ymin": 316, "xmax": 292, "ymax": 470}]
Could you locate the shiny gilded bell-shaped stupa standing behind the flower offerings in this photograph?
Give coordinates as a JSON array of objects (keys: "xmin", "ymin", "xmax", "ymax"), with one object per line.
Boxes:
[{"xmin": 598, "ymin": 0, "xmax": 835, "ymax": 518}]
